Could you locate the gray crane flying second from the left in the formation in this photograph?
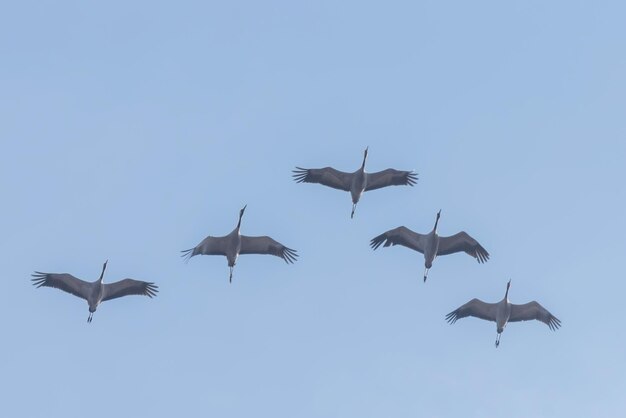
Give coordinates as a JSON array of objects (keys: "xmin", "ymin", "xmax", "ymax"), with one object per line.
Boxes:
[{"xmin": 182, "ymin": 205, "xmax": 298, "ymax": 282}]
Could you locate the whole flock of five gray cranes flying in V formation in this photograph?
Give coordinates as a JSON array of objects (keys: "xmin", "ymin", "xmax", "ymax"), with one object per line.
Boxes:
[{"xmin": 32, "ymin": 148, "xmax": 561, "ymax": 347}]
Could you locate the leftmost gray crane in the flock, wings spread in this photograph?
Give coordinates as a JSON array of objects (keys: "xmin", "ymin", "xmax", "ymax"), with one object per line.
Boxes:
[{"xmin": 32, "ymin": 260, "xmax": 158, "ymax": 322}]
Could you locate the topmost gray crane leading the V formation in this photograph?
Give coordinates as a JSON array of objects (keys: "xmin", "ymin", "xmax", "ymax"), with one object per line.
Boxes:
[{"xmin": 293, "ymin": 148, "xmax": 417, "ymax": 218}]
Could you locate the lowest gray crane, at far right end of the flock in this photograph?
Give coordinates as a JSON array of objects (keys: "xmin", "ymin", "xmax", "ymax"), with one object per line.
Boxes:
[{"xmin": 446, "ymin": 280, "xmax": 561, "ymax": 347}]
